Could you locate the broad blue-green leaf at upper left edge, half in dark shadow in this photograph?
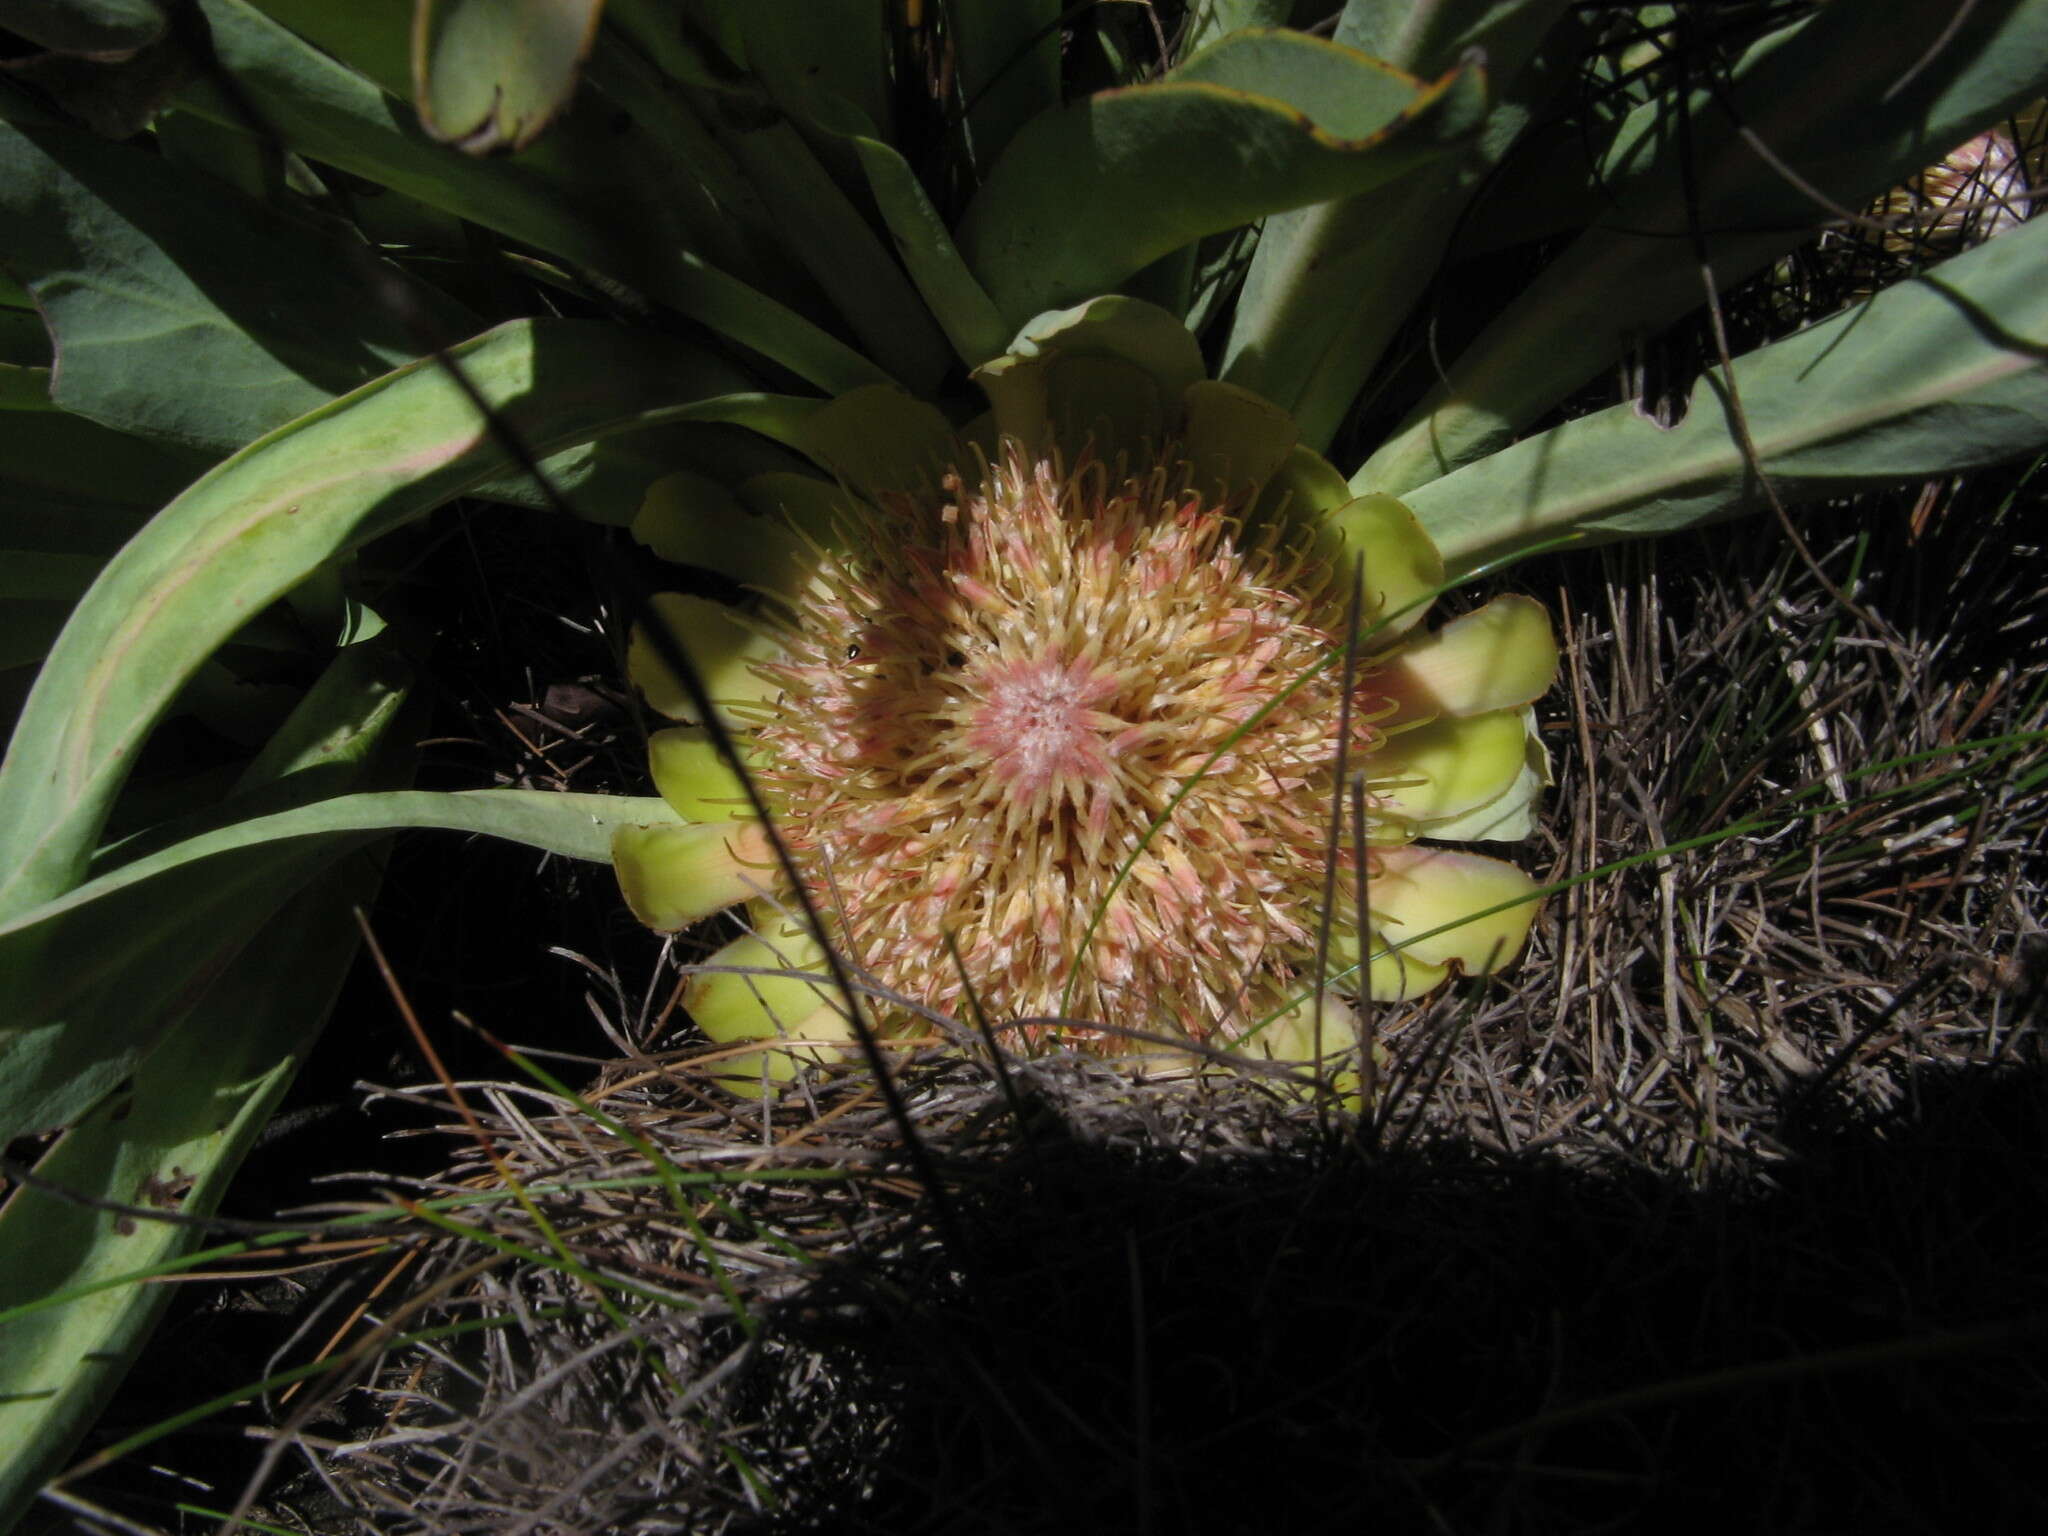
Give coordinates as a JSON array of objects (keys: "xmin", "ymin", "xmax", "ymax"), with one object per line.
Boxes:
[{"xmin": 0, "ymin": 125, "xmax": 475, "ymax": 453}]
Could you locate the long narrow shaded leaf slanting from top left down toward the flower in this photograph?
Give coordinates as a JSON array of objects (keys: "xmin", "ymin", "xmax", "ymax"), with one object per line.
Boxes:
[{"xmin": 190, "ymin": 0, "xmax": 887, "ymax": 393}]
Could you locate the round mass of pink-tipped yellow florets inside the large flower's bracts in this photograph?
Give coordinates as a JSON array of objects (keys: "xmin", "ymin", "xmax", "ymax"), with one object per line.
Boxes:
[{"xmin": 756, "ymin": 449, "xmax": 1386, "ymax": 1049}]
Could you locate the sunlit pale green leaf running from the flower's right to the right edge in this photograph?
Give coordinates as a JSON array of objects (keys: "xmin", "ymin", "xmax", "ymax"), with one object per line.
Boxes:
[{"xmin": 1405, "ymin": 219, "xmax": 2048, "ymax": 573}]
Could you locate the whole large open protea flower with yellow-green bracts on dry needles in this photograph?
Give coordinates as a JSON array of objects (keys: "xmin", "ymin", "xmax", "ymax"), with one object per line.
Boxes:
[{"xmin": 614, "ymin": 299, "xmax": 1556, "ymax": 1081}]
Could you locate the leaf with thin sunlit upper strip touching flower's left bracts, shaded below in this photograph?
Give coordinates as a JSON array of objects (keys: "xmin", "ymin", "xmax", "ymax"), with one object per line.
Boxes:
[{"xmin": 0, "ymin": 788, "xmax": 676, "ymax": 1141}]
